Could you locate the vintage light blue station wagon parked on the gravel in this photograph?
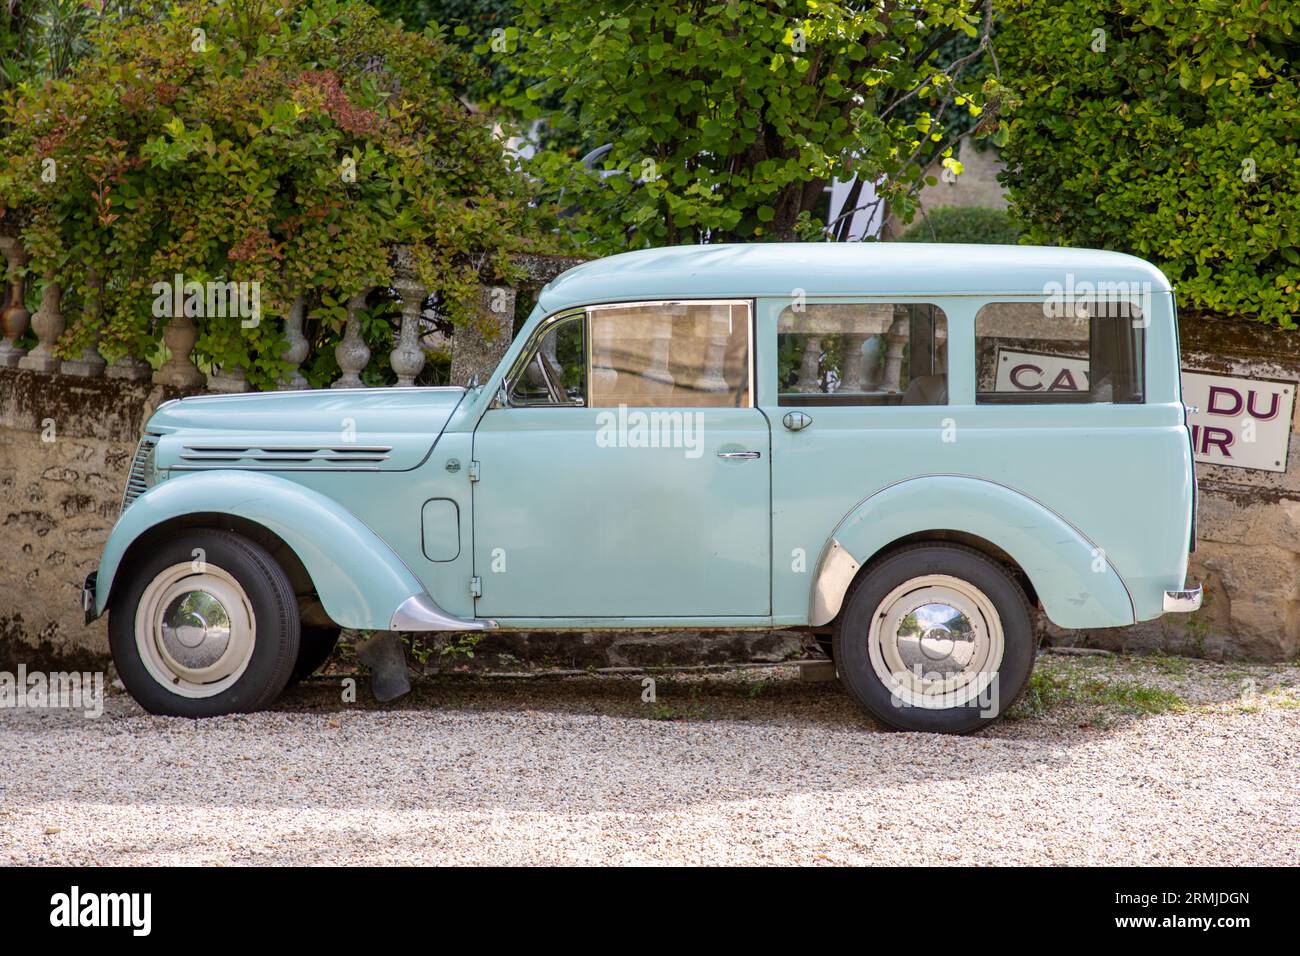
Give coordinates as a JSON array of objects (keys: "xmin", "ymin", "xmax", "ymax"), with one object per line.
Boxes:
[{"xmin": 85, "ymin": 243, "xmax": 1200, "ymax": 732}]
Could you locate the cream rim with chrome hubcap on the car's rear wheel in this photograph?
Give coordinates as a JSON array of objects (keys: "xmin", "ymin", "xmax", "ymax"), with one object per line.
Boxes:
[{"xmin": 867, "ymin": 575, "xmax": 1005, "ymax": 709}]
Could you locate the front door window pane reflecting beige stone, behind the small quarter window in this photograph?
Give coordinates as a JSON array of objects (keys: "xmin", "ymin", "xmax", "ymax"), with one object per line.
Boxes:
[{"xmin": 588, "ymin": 302, "xmax": 753, "ymax": 408}]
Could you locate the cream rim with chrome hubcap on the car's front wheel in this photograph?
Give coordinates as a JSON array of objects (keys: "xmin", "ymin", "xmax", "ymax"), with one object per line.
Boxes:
[{"xmin": 135, "ymin": 563, "xmax": 257, "ymax": 697}]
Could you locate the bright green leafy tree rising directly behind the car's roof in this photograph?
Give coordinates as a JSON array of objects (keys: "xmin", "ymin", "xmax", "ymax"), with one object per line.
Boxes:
[{"xmin": 499, "ymin": 0, "xmax": 1001, "ymax": 251}]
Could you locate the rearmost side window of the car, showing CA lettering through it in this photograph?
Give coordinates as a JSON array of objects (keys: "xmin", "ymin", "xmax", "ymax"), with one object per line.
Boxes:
[{"xmin": 975, "ymin": 302, "xmax": 1145, "ymax": 405}]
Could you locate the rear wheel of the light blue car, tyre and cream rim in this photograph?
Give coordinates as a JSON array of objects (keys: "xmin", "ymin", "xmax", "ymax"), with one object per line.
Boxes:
[{"xmin": 835, "ymin": 544, "xmax": 1034, "ymax": 734}]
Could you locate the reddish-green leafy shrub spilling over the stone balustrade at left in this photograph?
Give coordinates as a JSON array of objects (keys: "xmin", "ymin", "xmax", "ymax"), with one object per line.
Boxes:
[{"xmin": 0, "ymin": 0, "xmax": 530, "ymax": 385}]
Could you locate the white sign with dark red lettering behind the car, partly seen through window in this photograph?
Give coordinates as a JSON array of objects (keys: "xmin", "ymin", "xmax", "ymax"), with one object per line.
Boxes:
[{"xmin": 993, "ymin": 349, "xmax": 1296, "ymax": 472}]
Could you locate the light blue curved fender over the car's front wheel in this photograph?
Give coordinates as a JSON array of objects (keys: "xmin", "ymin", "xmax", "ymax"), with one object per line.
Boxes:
[{"xmin": 95, "ymin": 470, "xmax": 425, "ymax": 630}]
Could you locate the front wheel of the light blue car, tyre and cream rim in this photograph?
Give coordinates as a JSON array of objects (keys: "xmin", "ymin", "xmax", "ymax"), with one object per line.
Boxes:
[{"xmin": 108, "ymin": 529, "xmax": 299, "ymax": 717}]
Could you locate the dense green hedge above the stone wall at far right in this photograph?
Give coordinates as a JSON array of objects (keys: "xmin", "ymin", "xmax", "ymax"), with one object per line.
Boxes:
[{"xmin": 997, "ymin": 0, "xmax": 1300, "ymax": 329}]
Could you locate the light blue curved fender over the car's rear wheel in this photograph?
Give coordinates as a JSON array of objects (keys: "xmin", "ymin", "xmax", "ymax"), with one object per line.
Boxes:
[{"xmin": 810, "ymin": 475, "xmax": 1135, "ymax": 628}]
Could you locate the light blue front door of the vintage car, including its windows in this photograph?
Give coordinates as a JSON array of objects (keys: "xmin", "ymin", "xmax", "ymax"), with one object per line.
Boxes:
[{"xmin": 473, "ymin": 300, "xmax": 771, "ymax": 619}]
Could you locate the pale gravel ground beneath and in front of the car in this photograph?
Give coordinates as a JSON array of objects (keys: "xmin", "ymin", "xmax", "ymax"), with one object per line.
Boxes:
[{"xmin": 0, "ymin": 656, "xmax": 1300, "ymax": 865}]
